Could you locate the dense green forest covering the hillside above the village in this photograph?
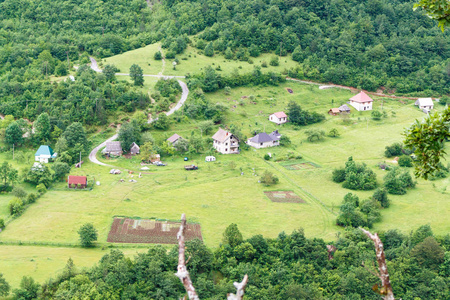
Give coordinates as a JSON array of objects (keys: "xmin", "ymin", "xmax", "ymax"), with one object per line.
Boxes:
[{"xmin": 0, "ymin": 0, "xmax": 450, "ymax": 123}]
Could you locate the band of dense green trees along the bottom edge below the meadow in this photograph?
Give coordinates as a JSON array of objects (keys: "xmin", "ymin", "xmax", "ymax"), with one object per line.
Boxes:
[{"xmin": 2, "ymin": 224, "xmax": 450, "ymax": 300}]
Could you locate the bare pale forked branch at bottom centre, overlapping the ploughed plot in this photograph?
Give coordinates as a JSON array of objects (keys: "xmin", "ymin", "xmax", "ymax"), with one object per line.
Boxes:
[{"xmin": 175, "ymin": 214, "xmax": 248, "ymax": 300}]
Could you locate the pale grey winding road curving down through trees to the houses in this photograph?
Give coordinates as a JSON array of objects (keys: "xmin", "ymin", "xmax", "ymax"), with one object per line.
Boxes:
[{"xmin": 89, "ymin": 57, "xmax": 189, "ymax": 167}]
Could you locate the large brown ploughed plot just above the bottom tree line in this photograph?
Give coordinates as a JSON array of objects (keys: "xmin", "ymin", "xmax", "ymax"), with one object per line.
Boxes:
[{"xmin": 107, "ymin": 218, "xmax": 203, "ymax": 244}]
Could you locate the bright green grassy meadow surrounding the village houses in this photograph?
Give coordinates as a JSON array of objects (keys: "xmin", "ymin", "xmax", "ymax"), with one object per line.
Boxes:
[{"xmin": 0, "ymin": 44, "xmax": 450, "ymax": 285}]
